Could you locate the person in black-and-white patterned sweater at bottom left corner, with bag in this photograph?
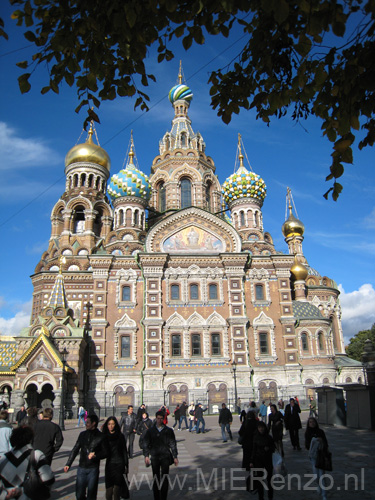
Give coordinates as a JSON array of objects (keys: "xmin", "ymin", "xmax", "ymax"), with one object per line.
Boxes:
[{"xmin": 0, "ymin": 425, "xmax": 55, "ymax": 500}]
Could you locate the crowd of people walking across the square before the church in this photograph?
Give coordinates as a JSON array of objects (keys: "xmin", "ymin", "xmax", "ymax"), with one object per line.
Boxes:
[{"xmin": 0, "ymin": 398, "xmax": 328, "ymax": 500}]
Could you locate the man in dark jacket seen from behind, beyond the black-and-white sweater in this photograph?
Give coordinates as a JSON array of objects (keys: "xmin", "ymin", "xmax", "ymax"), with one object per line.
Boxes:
[{"xmin": 33, "ymin": 408, "xmax": 64, "ymax": 465}]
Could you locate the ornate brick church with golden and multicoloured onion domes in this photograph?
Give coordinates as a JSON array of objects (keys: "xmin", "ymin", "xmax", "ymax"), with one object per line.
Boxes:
[{"xmin": 0, "ymin": 73, "xmax": 363, "ymax": 415}]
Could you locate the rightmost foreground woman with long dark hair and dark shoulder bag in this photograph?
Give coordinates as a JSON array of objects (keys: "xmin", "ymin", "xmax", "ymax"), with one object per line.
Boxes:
[{"xmin": 305, "ymin": 417, "xmax": 328, "ymax": 500}]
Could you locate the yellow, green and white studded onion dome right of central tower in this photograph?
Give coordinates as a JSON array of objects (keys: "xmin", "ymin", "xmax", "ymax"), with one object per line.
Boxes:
[{"xmin": 222, "ymin": 166, "xmax": 267, "ymax": 205}]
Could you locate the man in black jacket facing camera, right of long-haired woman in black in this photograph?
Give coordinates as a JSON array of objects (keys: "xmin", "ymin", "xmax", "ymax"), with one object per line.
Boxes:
[{"xmin": 143, "ymin": 410, "xmax": 178, "ymax": 500}]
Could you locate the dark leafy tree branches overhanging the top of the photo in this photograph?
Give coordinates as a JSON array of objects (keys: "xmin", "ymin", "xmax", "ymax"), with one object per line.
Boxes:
[{"xmin": 0, "ymin": 0, "xmax": 375, "ymax": 200}]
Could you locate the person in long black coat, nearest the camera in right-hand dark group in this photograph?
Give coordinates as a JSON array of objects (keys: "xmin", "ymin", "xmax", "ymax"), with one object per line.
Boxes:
[{"xmin": 250, "ymin": 422, "xmax": 275, "ymax": 500}]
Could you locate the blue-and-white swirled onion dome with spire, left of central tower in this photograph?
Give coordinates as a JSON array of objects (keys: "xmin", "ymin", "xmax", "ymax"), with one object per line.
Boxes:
[{"xmin": 107, "ymin": 138, "xmax": 151, "ymax": 202}]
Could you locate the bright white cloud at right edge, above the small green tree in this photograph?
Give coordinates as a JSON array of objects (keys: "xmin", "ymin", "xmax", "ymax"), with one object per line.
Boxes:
[{"xmin": 339, "ymin": 283, "xmax": 375, "ymax": 343}]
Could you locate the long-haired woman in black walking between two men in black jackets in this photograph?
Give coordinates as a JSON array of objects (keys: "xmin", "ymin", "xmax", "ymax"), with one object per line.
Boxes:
[{"xmin": 103, "ymin": 417, "xmax": 129, "ymax": 500}]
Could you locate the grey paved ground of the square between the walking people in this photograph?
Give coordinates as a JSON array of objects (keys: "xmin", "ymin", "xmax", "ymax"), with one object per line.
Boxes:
[{"xmin": 47, "ymin": 412, "xmax": 375, "ymax": 500}]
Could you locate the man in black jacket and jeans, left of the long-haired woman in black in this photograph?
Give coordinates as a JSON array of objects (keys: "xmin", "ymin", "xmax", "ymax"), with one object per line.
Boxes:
[{"xmin": 64, "ymin": 415, "xmax": 109, "ymax": 500}]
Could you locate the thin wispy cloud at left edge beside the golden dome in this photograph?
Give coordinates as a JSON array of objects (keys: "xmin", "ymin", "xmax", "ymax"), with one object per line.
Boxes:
[{"xmin": 0, "ymin": 122, "xmax": 61, "ymax": 171}]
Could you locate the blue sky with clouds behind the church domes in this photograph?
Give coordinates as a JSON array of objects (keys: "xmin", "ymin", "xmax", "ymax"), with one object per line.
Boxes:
[{"xmin": 0, "ymin": 3, "xmax": 375, "ymax": 339}]
